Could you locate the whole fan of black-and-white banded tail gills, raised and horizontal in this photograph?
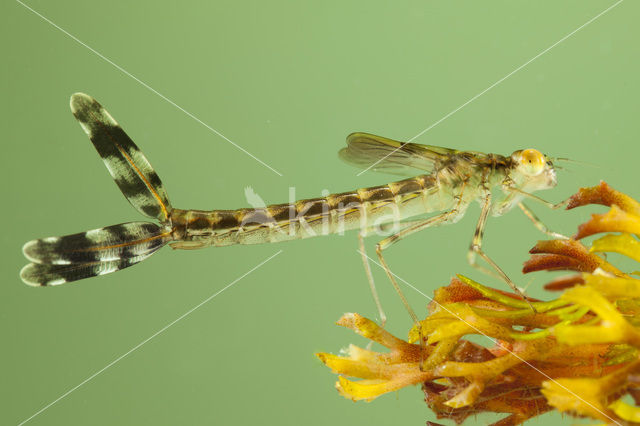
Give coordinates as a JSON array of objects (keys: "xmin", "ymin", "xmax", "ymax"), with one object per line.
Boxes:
[{"xmin": 20, "ymin": 93, "xmax": 172, "ymax": 286}]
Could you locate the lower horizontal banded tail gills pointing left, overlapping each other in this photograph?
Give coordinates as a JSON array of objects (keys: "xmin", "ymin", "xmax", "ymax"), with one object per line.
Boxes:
[{"xmin": 20, "ymin": 222, "xmax": 172, "ymax": 287}]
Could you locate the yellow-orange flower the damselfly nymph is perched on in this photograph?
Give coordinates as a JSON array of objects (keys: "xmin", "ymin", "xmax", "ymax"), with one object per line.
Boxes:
[{"xmin": 317, "ymin": 183, "xmax": 640, "ymax": 424}]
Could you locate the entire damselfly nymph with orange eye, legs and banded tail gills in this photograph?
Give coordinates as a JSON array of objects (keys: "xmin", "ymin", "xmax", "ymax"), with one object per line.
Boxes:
[{"xmin": 21, "ymin": 93, "xmax": 560, "ymax": 322}]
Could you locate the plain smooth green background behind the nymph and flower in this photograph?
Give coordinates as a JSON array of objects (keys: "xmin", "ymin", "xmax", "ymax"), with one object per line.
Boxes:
[{"xmin": 0, "ymin": 0, "xmax": 640, "ymax": 425}]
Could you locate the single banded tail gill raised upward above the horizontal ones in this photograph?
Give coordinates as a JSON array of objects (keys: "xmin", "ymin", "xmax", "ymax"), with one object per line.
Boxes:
[{"xmin": 71, "ymin": 93, "xmax": 171, "ymax": 222}]
